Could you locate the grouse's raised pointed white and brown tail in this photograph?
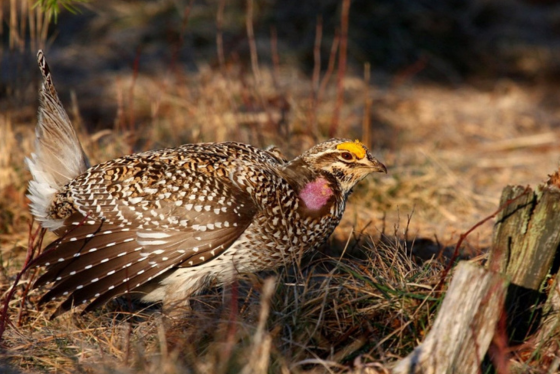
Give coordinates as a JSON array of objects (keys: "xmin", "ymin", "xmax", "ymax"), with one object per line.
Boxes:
[{"xmin": 26, "ymin": 50, "xmax": 89, "ymax": 230}]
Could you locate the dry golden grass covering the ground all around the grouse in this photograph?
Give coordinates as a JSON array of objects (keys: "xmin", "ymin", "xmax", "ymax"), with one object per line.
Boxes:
[{"xmin": 0, "ymin": 1, "xmax": 560, "ymax": 374}]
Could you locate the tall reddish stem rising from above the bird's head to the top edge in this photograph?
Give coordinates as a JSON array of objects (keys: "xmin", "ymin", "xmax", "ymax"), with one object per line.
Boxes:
[{"xmin": 329, "ymin": 0, "xmax": 350, "ymax": 138}]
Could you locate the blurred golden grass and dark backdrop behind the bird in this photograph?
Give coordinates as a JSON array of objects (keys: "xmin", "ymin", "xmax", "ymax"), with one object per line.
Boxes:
[{"xmin": 0, "ymin": 0, "xmax": 560, "ymax": 250}]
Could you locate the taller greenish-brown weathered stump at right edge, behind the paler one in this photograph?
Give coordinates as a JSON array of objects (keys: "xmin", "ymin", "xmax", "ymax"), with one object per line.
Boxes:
[{"xmin": 488, "ymin": 184, "xmax": 560, "ymax": 344}]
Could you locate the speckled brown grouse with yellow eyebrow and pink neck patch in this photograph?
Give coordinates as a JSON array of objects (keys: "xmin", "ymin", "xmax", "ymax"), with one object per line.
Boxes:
[{"xmin": 26, "ymin": 51, "xmax": 387, "ymax": 318}]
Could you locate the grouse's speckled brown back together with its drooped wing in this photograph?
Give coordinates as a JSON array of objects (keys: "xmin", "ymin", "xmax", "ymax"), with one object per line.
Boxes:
[{"xmin": 33, "ymin": 142, "xmax": 302, "ymax": 311}]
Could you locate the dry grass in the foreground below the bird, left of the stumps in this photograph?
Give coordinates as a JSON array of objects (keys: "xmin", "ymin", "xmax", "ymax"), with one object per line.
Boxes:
[{"xmin": 0, "ymin": 221, "xmax": 441, "ymax": 373}]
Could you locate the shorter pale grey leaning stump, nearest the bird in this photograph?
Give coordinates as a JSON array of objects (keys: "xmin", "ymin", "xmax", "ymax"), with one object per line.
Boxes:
[{"xmin": 392, "ymin": 262, "xmax": 508, "ymax": 374}]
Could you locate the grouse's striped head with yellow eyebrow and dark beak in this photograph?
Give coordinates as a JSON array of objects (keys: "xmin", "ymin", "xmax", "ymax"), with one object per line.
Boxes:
[{"xmin": 299, "ymin": 139, "xmax": 387, "ymax": 194}]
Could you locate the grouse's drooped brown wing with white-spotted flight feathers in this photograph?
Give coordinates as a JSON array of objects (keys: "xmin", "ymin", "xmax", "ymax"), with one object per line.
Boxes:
[{"xmin": 35, "ymin": 155, "xmax": 258, "ymax": 314}]
